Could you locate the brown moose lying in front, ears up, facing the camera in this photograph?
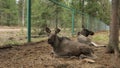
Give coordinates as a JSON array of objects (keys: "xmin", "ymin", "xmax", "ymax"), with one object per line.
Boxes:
[{"xmin": 46, "ymin": 27, "xmax": 94, "ymax": 58}]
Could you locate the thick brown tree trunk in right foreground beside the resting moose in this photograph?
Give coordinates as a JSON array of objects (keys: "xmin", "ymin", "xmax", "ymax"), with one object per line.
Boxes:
[{"xmin": 108, "ymin": 0, "xmax": 119, "ymax": 52}]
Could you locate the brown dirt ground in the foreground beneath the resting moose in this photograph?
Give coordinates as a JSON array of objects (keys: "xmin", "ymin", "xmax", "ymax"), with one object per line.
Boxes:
[{"xmin": 0, "ymin": 41, "xmax": 118, "ymax": 68}]
